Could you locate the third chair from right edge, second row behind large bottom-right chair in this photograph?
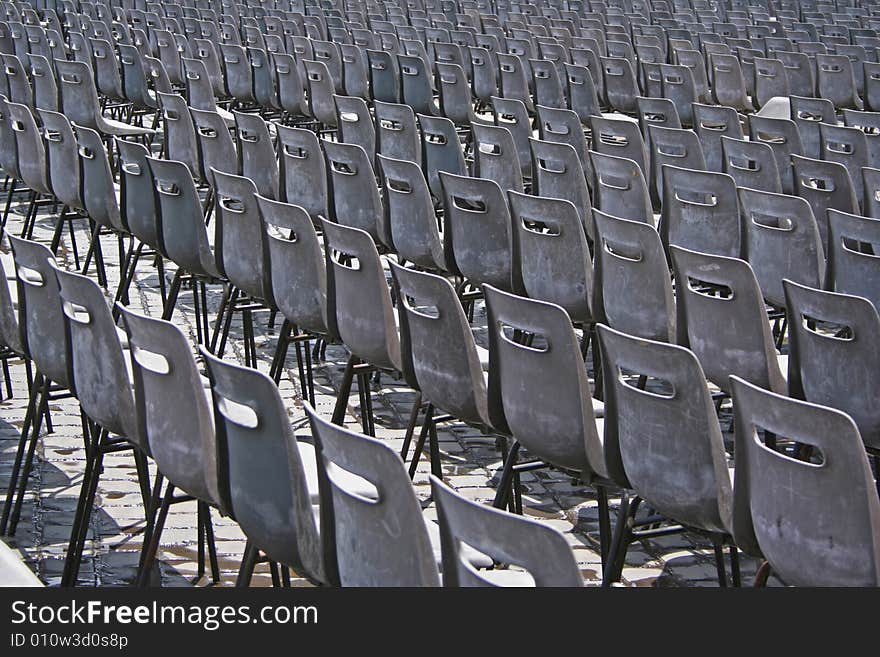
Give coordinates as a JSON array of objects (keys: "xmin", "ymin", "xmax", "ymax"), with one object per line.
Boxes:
[{"xmin": 659, "ymin": 165, "xmax": 741, "ymax": 258}]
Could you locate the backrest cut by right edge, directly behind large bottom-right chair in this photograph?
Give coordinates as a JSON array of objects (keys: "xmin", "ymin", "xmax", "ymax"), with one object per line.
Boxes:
[{"xmin": 784, "ymin": 281, "xmax": 880, "ymax": 449}]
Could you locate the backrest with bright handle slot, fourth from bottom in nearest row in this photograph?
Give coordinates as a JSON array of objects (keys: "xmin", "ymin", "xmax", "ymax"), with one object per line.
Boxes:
[{"xmin": 117, "ymin": 304, "xmax": 228, "ymax": 512}]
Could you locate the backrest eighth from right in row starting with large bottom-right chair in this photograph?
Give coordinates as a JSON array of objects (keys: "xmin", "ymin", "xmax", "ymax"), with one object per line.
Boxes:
[{"xmin": 147, "ymin": 157, "xmax": 220, "ymax": 278}]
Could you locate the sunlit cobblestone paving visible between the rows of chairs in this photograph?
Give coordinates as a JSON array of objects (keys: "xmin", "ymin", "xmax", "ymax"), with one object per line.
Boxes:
[{"xmin": 0, "ymin": 172, "xmax": 768, "ymax": 586}]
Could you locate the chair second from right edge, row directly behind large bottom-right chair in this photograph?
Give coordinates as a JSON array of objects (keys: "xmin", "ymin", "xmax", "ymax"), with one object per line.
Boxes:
[{"xmin": 669, "ymin": 246, "xmax": 787, "ymax": 393}]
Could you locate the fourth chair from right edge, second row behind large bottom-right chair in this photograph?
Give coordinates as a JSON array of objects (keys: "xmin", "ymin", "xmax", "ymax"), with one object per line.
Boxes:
[{"xmin": 590, "ymin": 151, "xmax": 654, "ymax": 226}]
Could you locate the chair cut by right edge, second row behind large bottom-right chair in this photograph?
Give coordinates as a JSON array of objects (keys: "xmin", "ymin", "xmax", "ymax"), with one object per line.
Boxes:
[{"xmin": 826, "ymin": 209, "xmax": 880, "ymax": 308}]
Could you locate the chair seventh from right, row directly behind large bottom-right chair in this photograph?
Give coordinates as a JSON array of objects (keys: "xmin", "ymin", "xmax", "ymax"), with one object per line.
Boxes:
[{"xmin": 323, "ymin": 141, "xmax": 393, "ymax": 248}]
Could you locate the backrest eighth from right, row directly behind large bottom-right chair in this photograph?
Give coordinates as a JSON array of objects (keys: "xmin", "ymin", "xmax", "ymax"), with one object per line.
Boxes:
[{"xmin": 275, "ymin": 123, "xmax": 329, "ymax": 222}]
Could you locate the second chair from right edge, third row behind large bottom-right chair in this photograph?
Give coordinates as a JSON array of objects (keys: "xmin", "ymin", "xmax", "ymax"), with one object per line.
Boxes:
[{"xmin": 791, "ymin": 155, "xmax": 859, "ymax": 252}]
